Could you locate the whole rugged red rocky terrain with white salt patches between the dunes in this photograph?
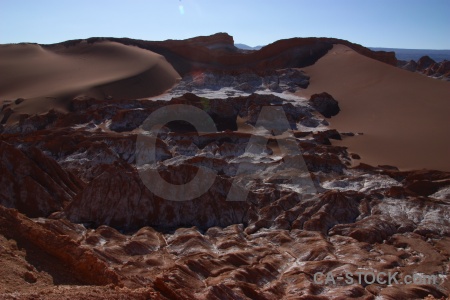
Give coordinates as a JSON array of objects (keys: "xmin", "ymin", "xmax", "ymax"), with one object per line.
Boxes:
[{"xmin": 0, "ymin": 35, "xmax": 450, "ymax": 299}]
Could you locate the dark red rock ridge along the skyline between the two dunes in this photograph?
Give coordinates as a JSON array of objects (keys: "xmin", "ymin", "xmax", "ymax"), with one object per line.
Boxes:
[{"xmin": 46, "ymin": 33, "xmax": 397, "ymax": 76}]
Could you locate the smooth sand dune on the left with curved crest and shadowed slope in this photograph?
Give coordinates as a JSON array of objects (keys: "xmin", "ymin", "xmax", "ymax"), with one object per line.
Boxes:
[{"xmin": 0, "ymin": 42, "xmax": 179, "ymax": 120}]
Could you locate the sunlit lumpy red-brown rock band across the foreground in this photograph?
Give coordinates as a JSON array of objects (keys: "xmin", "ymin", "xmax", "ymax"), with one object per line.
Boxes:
[{"xmin": 0, "ymin": 204, "xmax": 450, "ymax": 299}]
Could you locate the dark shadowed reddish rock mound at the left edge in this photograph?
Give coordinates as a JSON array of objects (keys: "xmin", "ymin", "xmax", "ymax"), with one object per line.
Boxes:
[{"xmin": 0, "ymin": 142, "xmax": 83, "ymax": 217}]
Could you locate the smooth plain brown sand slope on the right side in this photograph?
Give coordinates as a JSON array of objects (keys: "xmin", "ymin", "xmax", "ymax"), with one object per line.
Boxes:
[{"xmin": 300, "ymin": 45, "xmax": 450, "ymax": 171}]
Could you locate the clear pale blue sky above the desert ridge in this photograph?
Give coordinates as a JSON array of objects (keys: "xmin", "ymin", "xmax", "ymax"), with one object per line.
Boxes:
[{"xmin": 0, "ymin": 0, "xmax": 450, "ymax": 49}]
